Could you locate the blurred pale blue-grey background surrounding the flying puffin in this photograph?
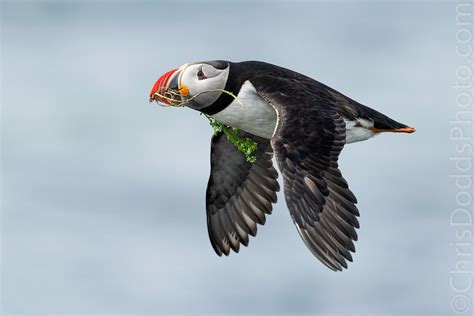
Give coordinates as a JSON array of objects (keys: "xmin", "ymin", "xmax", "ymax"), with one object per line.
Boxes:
[{"xmin": 1, "ymin": 0, "xmax": 461, "ymax": 315}]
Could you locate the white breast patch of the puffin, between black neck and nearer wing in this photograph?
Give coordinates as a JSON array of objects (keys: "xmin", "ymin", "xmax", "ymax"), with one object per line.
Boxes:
[{"xmin": 212, "ymin": 81, "xmax": 277, "ymax": 139}]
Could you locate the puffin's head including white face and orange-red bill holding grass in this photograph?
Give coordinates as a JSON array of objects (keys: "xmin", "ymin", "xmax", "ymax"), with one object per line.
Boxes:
[{"xmin": 150, "ymin": 60, "xmax": 230, "ymax": 111}]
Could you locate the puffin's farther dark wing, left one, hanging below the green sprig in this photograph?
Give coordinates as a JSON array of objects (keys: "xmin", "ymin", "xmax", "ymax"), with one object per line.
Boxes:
[{"xmin": 206, "ymin": 132, "xmax": 280, "ymax": 256}]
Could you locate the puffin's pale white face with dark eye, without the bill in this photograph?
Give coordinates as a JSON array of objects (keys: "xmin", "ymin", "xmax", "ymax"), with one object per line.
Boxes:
[{"xmin": 179, "ymin": 63, "xmax": 230, "ymax": 110}]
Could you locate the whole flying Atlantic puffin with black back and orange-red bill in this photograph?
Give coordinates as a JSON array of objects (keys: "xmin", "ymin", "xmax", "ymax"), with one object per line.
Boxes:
[{"xmin": 150, "ymin": 60, "xmax": 415, "ymax": 271}]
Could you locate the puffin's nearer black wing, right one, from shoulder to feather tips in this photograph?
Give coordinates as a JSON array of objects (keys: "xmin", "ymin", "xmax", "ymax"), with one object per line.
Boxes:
[{"xmin": 256, "ymin": 70, "xmax": 359, "ymax": 270}]
